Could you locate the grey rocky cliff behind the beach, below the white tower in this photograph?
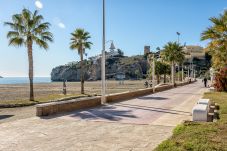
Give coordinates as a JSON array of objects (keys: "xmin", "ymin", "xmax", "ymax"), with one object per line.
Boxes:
[{"xmin": 51, "ymin": 56, "xmax": 149, "ymax": 81}]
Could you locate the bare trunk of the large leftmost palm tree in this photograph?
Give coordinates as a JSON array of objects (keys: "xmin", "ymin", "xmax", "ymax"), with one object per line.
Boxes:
[{"xmin": 28, "ymin": 42, "xmax": 35, "ymax": 101}]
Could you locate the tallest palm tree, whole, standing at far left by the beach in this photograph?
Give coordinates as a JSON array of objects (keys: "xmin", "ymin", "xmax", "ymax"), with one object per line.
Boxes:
[{"xmin": 4, "ymin": 9, "xmax": 53, "ymax": 101}]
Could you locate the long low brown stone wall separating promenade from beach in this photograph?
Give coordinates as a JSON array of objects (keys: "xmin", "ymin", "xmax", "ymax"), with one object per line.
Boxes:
[{"xmin": 36, "ymin": 81, "xmax": 194, "ymax": 116}]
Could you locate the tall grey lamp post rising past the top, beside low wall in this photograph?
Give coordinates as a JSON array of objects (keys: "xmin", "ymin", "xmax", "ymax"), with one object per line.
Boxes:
[{"xmin": 101, "ymin": 0, "xmax": 106, "ymax": 104}]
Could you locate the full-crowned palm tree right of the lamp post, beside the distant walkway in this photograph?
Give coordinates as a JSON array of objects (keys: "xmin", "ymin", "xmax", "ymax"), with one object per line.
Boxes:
[{"xmin": 161, "ymin": 42, "xmax": 184, "ymax": 84}]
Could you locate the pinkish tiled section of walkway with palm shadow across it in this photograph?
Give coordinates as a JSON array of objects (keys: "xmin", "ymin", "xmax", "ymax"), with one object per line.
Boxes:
[{"xmin": 58, "ymin": 84, "xmax": 201, "ymax": 124}]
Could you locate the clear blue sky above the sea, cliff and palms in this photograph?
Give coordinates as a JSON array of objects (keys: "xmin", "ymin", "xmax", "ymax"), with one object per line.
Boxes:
[{"xmin": 0, "ymin": 0, "xmax": 227, "ymax": 77}]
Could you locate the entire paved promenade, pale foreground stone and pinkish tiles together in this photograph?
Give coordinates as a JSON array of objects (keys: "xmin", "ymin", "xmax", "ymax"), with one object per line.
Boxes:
[{"xmin": 0, "ymin": 81, "xmax": 206, "ymax": 151}]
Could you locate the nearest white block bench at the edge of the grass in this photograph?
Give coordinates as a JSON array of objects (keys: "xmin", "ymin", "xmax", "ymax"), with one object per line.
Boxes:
[{"xmin": 192, "ymin": 104, "xmax": 208, "ymax": 121}]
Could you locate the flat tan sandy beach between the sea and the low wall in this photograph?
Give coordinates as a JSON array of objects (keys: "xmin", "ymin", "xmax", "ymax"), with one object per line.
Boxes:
[{"xmin": 0, "ymin": 80, "xmax": 145, "ymax": 101}]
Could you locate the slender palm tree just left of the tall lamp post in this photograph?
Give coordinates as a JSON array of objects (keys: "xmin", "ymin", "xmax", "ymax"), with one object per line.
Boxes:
[{"xmin": 70, "ymin": 28, "xmax": 92, "ymax": 94}]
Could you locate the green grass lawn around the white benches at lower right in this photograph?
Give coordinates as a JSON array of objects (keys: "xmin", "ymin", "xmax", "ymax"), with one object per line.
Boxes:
[{"xmin": 155, "ymin": 92, "xmax": 227, "ymax": 151}]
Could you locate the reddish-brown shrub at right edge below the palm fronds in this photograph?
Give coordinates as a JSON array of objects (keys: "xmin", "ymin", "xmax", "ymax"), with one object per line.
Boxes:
[{"xmin": 214, "ymin": 67, "xmax": 227, "ymax": 92}]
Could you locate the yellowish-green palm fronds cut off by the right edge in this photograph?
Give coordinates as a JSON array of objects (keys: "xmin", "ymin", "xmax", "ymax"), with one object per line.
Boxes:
[{"xmin": 201, "ymin": 10, "xmax": 227, "ymax": 69}]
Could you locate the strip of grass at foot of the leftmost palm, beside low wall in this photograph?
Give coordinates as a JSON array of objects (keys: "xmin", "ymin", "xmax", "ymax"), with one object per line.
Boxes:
[{"xmin": 0, "ymin": 94, "xmax": 88, "ymax": 107}]
